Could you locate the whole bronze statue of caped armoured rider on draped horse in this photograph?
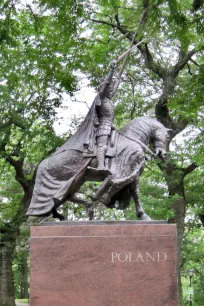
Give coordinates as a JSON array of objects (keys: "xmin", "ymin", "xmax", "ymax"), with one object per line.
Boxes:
[{"xmin": 27, "ymin": 62, "xmax": 171, "ymax": 220}]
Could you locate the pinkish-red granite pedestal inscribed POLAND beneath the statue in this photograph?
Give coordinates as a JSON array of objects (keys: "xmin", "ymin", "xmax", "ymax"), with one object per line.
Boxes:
[{"xmin": 31, "ymin": 223, "xmax": 177, "ymax": 306}]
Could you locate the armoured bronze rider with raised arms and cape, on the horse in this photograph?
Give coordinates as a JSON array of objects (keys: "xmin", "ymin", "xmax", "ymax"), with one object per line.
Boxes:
[{"xmin": 55, "ymin": 62, "xmax": 119, "ymax": 174}]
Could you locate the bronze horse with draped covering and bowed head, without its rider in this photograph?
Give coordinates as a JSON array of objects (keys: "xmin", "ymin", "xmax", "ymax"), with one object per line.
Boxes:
[{"xmin": 27, "ymin": 117, "xmax": 169, "ymax": 220}]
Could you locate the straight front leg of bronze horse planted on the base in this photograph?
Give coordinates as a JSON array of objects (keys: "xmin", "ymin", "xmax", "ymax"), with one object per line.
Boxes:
[{"xmin": 131, "ymin": 175, "xmax": 151, "ymax": 221}]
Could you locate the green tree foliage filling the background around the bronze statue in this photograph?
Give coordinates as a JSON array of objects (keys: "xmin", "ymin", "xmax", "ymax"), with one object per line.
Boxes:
[{"xmin": 0, "ymin": 0, "xmax": 204, "ymax": 306}]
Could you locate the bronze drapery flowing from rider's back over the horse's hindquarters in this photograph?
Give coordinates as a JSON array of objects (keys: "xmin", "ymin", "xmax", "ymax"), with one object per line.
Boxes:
[{"xmin": 27, "ymin": 95, "xmax": 101, "ymax": 216}]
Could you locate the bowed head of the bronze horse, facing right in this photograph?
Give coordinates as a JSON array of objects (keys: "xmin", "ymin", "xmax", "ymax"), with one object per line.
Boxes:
[{"xmin": 152, "ymin": 121, "xmax": 170, "ymax": 159}]
